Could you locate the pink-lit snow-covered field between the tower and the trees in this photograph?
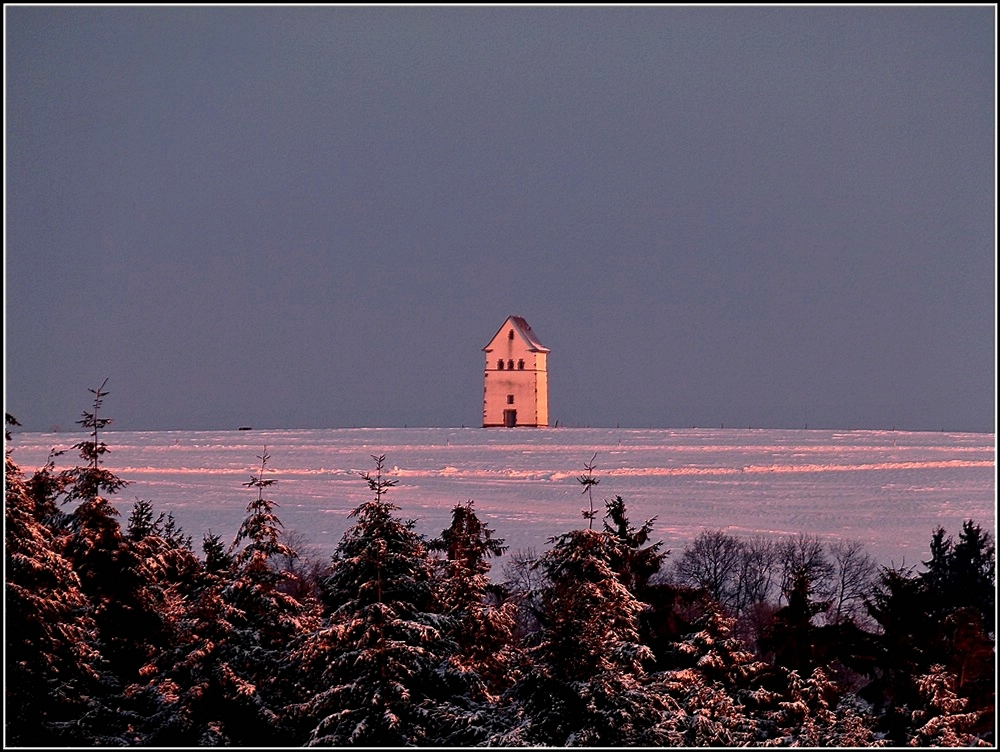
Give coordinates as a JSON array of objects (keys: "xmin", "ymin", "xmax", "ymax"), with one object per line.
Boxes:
[{"xmin": 11, "ymin": 428, "xmax": 996, "ymax": 565}]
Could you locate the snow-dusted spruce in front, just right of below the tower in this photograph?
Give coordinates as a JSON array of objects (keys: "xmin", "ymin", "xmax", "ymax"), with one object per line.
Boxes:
[{"xmin": 500, "ymin": 530, "xmax": 670, "ymax": 746}]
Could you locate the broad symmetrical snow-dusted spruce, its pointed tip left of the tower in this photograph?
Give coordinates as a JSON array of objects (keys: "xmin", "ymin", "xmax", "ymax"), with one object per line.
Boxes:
[{"xmin": 290, "ymin": 456, "xmax": 453, "ymax": 746}]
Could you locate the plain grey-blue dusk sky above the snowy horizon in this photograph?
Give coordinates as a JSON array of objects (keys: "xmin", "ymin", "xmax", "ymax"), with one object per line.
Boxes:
[{"xmin": 4, "ymin": 5, "xmax": 997, "ymax": 432}]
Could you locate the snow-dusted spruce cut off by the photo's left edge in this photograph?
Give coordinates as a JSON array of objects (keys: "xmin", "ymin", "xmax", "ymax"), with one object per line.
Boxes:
[{"xmin": 4, "ymin": 415, "xmax": 101, "ymax": 747}]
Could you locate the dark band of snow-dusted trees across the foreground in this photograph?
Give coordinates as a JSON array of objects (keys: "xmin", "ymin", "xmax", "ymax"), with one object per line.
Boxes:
[{"xmin": 4, "ymin": 384, "xmax": 996, "ymax": 747}]
